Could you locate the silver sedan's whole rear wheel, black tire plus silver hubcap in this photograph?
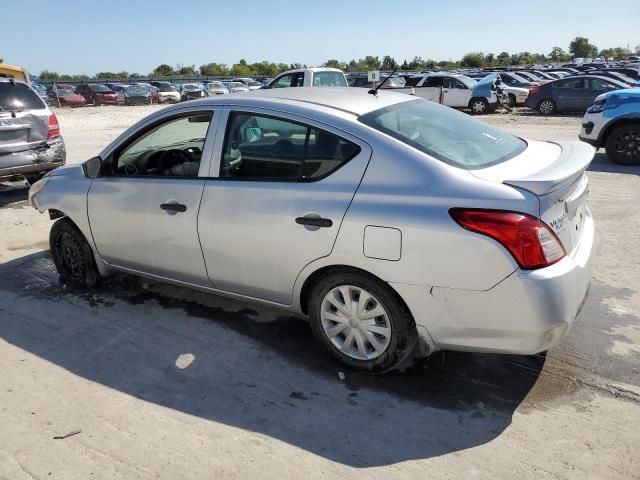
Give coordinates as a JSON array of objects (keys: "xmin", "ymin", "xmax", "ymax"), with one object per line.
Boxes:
[{"xmin": 308, "ymin": 269, "xmax": 418, "ymax": 374}]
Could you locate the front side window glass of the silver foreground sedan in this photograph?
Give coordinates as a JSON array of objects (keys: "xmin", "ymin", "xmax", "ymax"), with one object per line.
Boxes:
[{"xmin": 113, "ymin": 112, "xmax": 213, "ymax": 177}]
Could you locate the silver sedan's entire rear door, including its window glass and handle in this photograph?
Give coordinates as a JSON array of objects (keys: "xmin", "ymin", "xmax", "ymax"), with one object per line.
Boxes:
[{"xmin": 198, "ymin": 107, "xmax": 371, "ymax": 304}]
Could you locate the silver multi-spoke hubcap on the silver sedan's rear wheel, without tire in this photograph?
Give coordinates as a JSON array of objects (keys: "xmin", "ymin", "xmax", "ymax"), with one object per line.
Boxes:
[{"xmin": 320, "ymin": 285, "xmax": 391, "ymax": 360}]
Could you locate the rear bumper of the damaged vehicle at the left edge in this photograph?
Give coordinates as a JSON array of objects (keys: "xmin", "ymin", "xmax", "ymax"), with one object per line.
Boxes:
[{"xmin": 0, "ymin": 138, "xmax": 67, "ymax": 178}]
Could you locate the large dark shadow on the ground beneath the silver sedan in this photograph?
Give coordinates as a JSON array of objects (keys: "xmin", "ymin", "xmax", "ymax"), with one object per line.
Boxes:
[{"xmin": 0, "ymin": 252, "xmax": 632, "ymax": 467}]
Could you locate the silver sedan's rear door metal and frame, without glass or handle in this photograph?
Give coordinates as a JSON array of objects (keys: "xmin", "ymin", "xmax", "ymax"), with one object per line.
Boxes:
[{"xmin": 198, "ymin": 109, "xmax": 371, "ymax": 304}]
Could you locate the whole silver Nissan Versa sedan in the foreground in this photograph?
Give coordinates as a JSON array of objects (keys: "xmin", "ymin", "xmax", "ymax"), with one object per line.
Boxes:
[{"xmin": 29, "ymin": 88, "xmax": 594, "ymax": 373}]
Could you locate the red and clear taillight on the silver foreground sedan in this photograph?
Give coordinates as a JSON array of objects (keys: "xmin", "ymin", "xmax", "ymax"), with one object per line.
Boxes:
[{"xmin": 449, "ymin": 208, "xmax": 566, "ymax": 270}]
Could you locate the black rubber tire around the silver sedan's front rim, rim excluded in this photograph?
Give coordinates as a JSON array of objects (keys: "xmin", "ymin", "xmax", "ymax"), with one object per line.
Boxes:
[{"xmin": 49, "ymin": 218, "xmax": 100, "ymax": 291}]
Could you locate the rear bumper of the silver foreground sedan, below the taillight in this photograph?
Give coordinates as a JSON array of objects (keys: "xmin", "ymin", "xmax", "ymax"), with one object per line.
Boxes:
[{"xmin": 392, "ymin": 214, "xmax": 594, "ymax": 354}]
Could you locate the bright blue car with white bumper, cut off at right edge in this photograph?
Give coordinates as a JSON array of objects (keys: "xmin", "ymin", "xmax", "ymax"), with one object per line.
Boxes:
[{"xmin": 580, "ymin": 88, "xmax": 640, "ymax": 165}]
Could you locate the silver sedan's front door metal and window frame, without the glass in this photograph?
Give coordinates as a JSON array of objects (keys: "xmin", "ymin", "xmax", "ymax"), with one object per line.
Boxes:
[{"xmin": 87, "ymin": 108, "xmax": 221, "ymax": 286}]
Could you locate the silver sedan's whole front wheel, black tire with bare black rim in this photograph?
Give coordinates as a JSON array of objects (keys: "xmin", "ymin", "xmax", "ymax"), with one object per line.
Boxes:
[{"xmin": 49, "ymin": 218, "xmax": 100, "ymax": 291}]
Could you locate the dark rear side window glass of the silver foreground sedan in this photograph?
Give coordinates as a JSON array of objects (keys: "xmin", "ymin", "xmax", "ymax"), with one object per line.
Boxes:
[{"xmin": 220, "ymin": 112, "xmax": 360, "ymax": 182}]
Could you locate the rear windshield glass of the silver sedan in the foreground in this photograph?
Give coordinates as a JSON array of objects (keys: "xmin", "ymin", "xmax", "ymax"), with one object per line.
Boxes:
[{"xmin": 359, "ymin": 100, "xmax": 527, "ymax": 170}]
